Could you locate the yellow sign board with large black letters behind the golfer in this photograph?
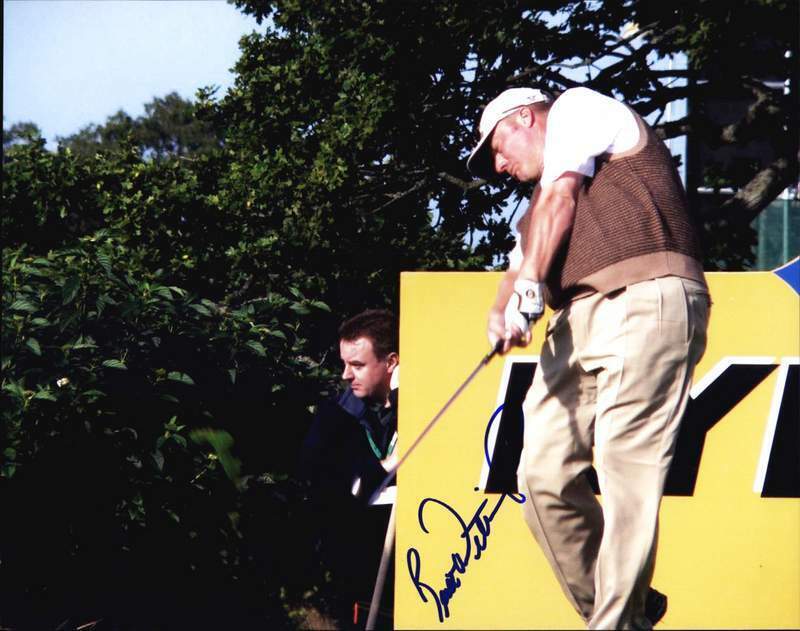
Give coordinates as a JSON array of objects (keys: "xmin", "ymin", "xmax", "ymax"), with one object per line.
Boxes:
[{"xmin": 395, "ymin": 268, "xmax": 800, "ymax": 629}]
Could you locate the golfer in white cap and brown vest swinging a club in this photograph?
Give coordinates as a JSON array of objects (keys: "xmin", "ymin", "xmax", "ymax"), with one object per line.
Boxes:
[{"xmin": 467, "ymin": 88, "xmax": 710, "ymax": 629}]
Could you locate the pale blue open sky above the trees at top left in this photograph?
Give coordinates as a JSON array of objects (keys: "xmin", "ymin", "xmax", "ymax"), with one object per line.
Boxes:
[{"xmin": 3, "ymin": 0, "xmax": 264, "ymax": 147}]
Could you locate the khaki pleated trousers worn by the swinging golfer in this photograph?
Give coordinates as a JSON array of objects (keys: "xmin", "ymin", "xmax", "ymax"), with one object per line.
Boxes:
[{"xmin": 517, "ymin": 276, "xmax": 710, "ymax": 629}]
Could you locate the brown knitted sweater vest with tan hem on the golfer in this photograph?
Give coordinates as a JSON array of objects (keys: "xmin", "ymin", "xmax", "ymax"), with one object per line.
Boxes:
[{"xmin": 517, "ymin": 116, "xmax": 705, "ymax": 308}]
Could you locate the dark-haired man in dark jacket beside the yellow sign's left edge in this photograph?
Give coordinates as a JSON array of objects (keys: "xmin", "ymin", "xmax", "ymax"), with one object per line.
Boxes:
[{"xmin": 301, "ymin": 309, "xmax": 400, "ymax": 626}]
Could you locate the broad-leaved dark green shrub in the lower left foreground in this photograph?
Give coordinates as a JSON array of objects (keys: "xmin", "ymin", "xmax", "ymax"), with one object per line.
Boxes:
[{"xmin": 0, "ymin": 222, "xmax": 330, "ymax": 627}]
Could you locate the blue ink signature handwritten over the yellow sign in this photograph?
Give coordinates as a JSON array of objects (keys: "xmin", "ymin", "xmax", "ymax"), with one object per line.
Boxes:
[{"xmin": 406, "ymin": 405, "xmax": 525, "ymax": 622}]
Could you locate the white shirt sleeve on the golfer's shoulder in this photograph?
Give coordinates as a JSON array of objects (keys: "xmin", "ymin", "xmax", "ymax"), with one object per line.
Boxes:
[{"xmin": 541, "ymin": 88, "xmax": 639, "ymax": 184}]
